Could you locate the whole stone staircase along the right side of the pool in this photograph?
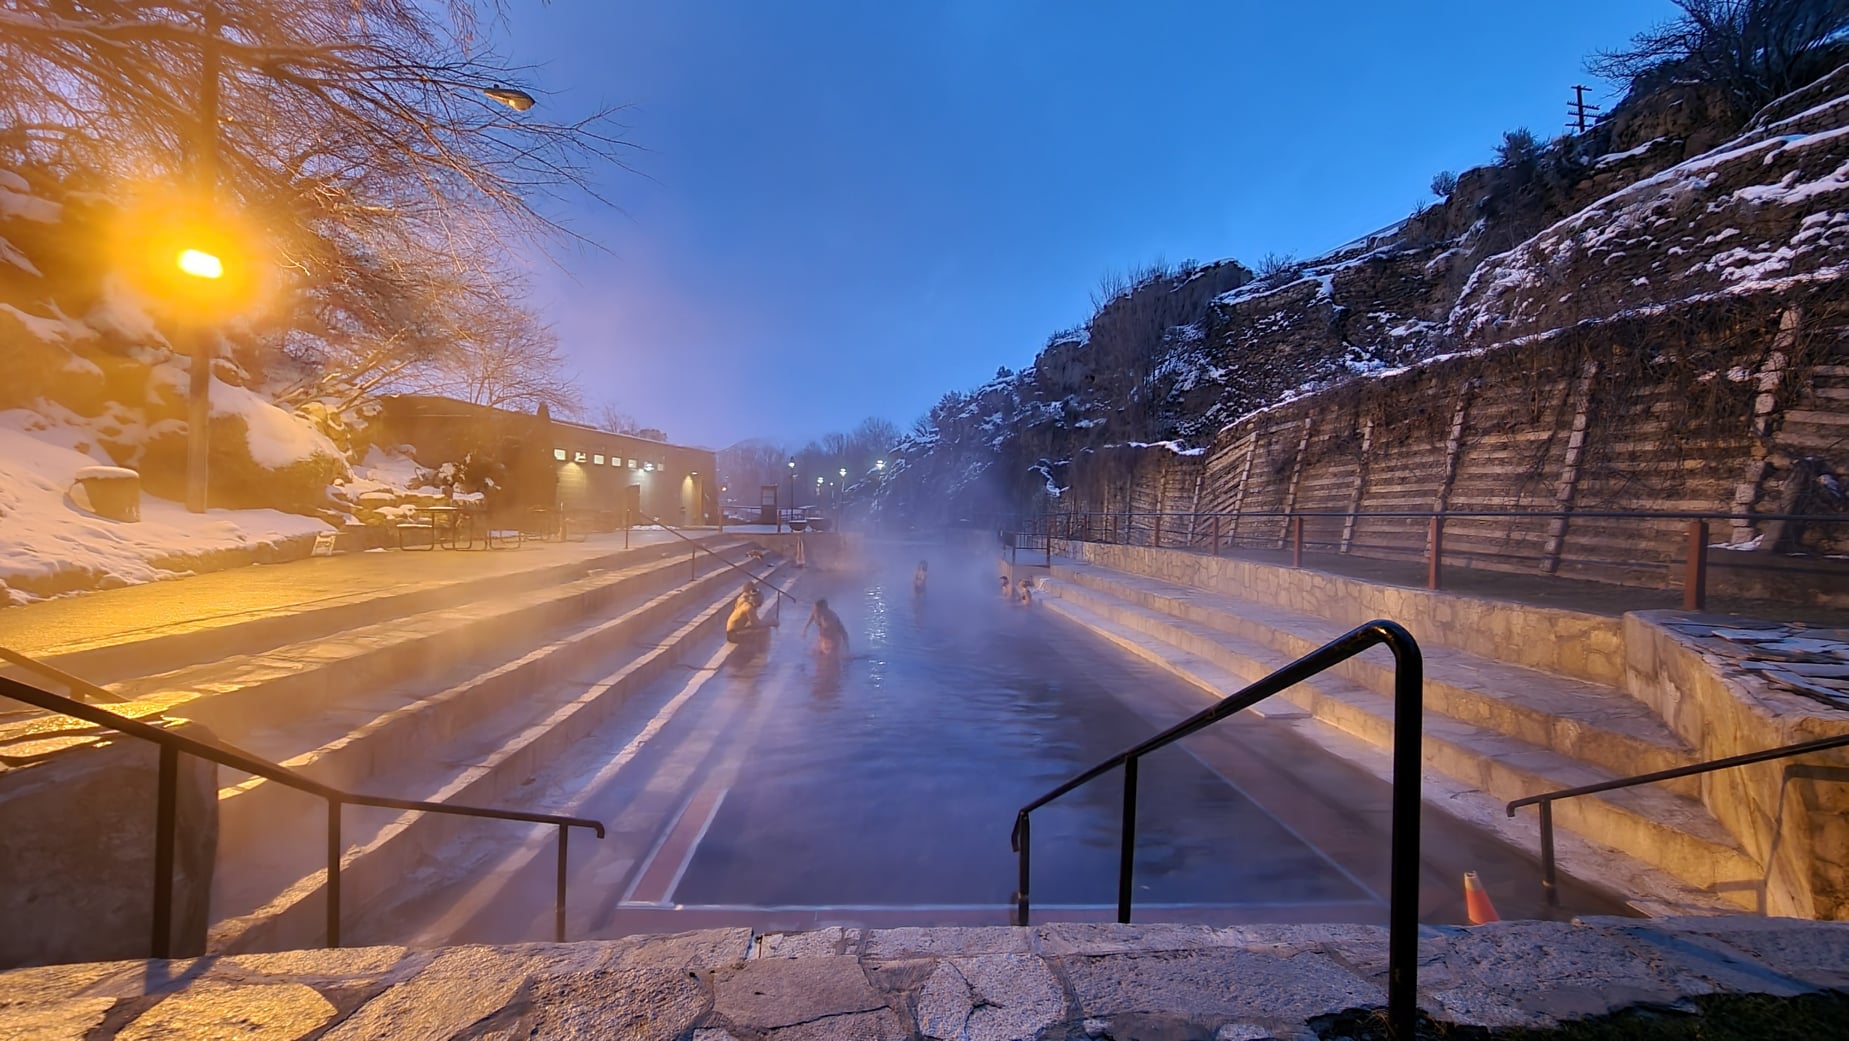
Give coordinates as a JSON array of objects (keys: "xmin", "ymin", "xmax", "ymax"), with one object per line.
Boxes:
[{"xmin": 1045, "ymin": 557, "xmax": 1764, "ymax": 913}]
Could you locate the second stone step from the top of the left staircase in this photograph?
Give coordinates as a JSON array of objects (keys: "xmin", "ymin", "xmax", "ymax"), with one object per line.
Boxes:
[{"xmin": 106, "ymin": 544, "xmax": 758, "ymax": 756}]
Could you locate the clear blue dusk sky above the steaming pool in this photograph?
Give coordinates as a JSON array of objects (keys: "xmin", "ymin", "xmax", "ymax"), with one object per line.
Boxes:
[{"xmin": 499, "ymin": 0, "xmax": 1671, "ymax": 447}]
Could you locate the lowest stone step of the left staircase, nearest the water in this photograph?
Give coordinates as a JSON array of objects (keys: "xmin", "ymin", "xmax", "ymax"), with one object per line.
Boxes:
[{"xmin": 207, "ymin": 571, "xmax": 775, "ymax": 952}]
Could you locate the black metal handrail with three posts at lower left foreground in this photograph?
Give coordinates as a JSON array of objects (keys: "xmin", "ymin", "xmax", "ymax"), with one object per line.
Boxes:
[{"xmin": 0, "ymin": 655, "xmax": 603, "ymax": 958}]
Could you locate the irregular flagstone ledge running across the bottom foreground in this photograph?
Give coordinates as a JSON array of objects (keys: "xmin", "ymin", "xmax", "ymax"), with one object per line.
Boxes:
[{"xmin": 0, "ymin": 917, "xmax": 1849, "ymax": 1041}]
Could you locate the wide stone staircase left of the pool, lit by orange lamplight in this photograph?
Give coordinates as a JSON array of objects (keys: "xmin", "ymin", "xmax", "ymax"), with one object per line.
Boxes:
[{"xmin": 14, "ymin": 533, "xmax": 795, "ymax": 952}]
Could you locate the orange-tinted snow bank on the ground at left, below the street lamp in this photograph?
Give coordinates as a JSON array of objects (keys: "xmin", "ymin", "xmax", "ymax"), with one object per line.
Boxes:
[{"xmin": 0, "ymin": 409, "xmax": 329, "ymax": 603}]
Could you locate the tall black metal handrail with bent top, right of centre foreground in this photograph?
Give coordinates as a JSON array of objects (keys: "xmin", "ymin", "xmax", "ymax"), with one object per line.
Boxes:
[{"xmin": 1010, "ymin": 619, "xmax": 1426, "ymax": 1041}]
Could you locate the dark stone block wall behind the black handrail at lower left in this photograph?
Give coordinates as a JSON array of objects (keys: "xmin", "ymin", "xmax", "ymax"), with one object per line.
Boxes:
[{"xmin": 0, "ymin": 716, "xmax": 218, "ymax": 968}]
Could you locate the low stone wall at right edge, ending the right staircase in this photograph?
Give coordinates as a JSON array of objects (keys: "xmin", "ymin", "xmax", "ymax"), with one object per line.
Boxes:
[{"xmin": 1623, "ymin": 612, "xmax": 1849, "ymax": 919}]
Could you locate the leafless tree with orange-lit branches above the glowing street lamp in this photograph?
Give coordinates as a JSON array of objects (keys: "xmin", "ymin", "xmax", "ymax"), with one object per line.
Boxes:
[{"xmin": 0, "ymin": 0, "xmax": 625, "ymax": 412}]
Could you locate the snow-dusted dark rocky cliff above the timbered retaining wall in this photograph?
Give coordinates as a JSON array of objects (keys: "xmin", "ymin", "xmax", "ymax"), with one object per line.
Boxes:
[{"xmin": 873, "ymin": 68, "xmax": 1849, "ymax": 523}]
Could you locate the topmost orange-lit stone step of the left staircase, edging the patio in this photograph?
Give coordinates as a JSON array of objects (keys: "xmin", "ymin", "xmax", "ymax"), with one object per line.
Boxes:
[{"xmin": 39, "ymin": 533, "xmax": 736, "ymax": 686}]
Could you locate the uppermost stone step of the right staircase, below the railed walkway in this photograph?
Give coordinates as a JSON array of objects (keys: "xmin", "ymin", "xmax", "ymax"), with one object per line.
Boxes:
[{"xmin": 1054, "ymin": 558, "xmax": 1699, "ymax": 797}]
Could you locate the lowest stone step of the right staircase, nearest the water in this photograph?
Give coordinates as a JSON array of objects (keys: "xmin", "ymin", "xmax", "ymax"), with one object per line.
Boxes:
[{"xmin": 1045, "ymin": 581, "xmax": 1762, "ymax": 910}]
